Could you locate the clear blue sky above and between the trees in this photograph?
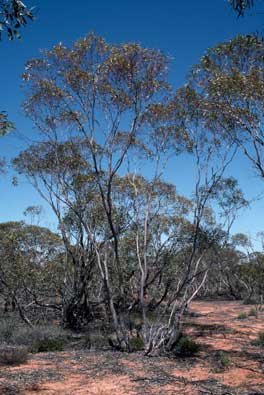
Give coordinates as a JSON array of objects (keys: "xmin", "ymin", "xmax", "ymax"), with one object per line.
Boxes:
[{"xmin": 0, "ymin": 0, "xmax": 264, "ymax": 248}]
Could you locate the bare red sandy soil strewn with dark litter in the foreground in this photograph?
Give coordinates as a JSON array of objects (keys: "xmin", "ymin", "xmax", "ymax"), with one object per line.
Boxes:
[{"xmin": 0, "ymin": 301, "xmax": 264, "ymax": 395}]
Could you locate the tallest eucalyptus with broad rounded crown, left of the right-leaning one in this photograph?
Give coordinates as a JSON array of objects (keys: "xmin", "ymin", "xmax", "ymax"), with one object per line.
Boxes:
[{"xmin": 13, "ymin": 34, "xmax": 176, "ymax": 348}]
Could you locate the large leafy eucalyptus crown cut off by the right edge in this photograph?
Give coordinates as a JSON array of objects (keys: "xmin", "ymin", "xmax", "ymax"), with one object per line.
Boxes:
[{"xmin": 186, "ymin": 35, "xmax": 264, "ymax": 177}]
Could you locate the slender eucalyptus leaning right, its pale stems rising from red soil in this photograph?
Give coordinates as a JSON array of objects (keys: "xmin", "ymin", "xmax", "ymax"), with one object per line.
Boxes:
[{"xmin": 135, "ymin": 85, "xmax": 248, "ymax": 353}]
